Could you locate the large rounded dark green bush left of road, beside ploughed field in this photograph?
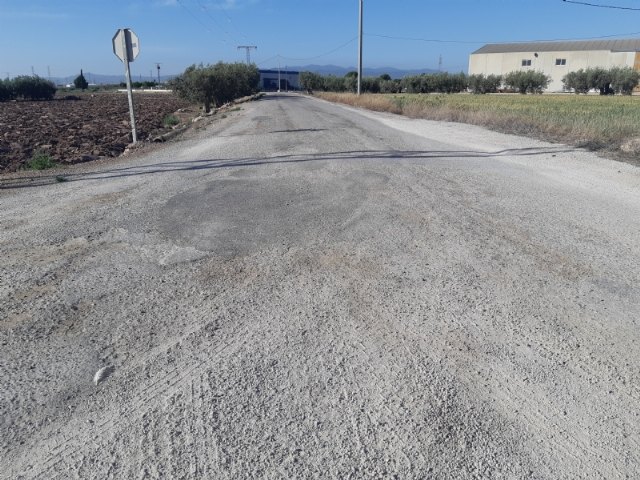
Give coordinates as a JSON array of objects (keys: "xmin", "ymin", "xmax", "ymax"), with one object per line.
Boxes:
[{"xmin": 169, "ymin": 62, "xmax": 260, "ymax": 112}]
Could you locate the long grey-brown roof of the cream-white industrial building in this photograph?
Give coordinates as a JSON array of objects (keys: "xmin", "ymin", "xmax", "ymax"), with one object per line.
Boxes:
[{"xmin": 472, "ymin": 38, "xmax": 640, "ymax": 55}]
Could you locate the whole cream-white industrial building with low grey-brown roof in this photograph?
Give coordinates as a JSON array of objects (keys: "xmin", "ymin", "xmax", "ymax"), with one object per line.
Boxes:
[{"xmin": 469, "ymin": 39, "xmax": 640, "ymax": 92}]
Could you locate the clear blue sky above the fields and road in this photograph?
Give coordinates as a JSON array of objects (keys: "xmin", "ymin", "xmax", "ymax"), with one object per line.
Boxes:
[{"xmin": 0, "ymin": 0, "xmax": 640, "ymax": 78}]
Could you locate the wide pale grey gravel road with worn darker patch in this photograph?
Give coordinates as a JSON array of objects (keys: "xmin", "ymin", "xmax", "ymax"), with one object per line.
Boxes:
[{"xmin": 0, "ymin": 94, "xmax": 640, "ymax": 479}]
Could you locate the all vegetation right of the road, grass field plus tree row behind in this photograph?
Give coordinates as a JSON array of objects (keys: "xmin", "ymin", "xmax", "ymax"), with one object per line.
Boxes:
[{"xmin": 300, "ymin": 68, "xmax": 640, "ymax": 157}]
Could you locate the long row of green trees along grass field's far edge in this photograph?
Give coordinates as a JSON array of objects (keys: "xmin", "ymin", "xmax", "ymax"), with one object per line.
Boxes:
[{"xmin": 300, "ymin": 67, "xmax": 640, "ymax": 95}]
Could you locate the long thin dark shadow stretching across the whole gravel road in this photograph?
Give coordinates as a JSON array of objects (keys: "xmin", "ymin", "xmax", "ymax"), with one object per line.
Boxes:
[{"xmin": 0, "ymin": 147, "xmax": 576, "ymax": 190}]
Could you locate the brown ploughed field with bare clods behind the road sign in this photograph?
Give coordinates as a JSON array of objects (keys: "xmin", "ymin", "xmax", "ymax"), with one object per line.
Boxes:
[{"xmin": 0, "ymin": 92, "xmax": 189, "ymax": 172}]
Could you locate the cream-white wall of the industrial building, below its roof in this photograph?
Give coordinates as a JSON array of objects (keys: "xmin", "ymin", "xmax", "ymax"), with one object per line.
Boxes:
[{"xmin": 469, "ymin": 50, "xmax": 640, "ymax": 92}]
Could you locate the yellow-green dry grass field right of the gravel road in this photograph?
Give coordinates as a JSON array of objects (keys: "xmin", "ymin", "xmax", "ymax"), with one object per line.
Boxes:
[{"xmin": 318, "ymin": 93, "xmax": 640, "ymax": 156}]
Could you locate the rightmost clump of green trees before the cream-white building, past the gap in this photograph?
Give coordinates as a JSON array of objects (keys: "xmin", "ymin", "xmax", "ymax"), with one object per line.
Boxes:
[{"xmin": 562, "ymin": 67, "xmax": 640, "ymax": 95}]
